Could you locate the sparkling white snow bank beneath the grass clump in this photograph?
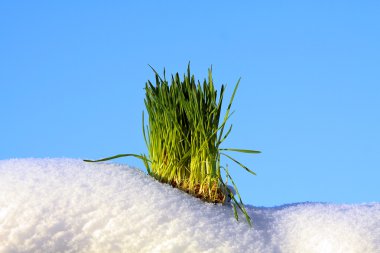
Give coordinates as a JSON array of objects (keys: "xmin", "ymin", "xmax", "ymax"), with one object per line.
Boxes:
[{"xmin": 0, "ymin": 159, "xmax": 380, "ymax": 253}]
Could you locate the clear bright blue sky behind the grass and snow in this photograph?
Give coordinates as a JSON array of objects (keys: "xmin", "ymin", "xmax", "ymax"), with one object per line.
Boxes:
[{"xmin": 0, "ymin": 0, "xmax": 380, "ymax": 206}]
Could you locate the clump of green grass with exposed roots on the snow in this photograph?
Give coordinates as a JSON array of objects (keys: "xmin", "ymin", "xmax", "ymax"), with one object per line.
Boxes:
[{"xmin": 85, "ymin": 64, "xmax": 260, "ymax": 224}]
